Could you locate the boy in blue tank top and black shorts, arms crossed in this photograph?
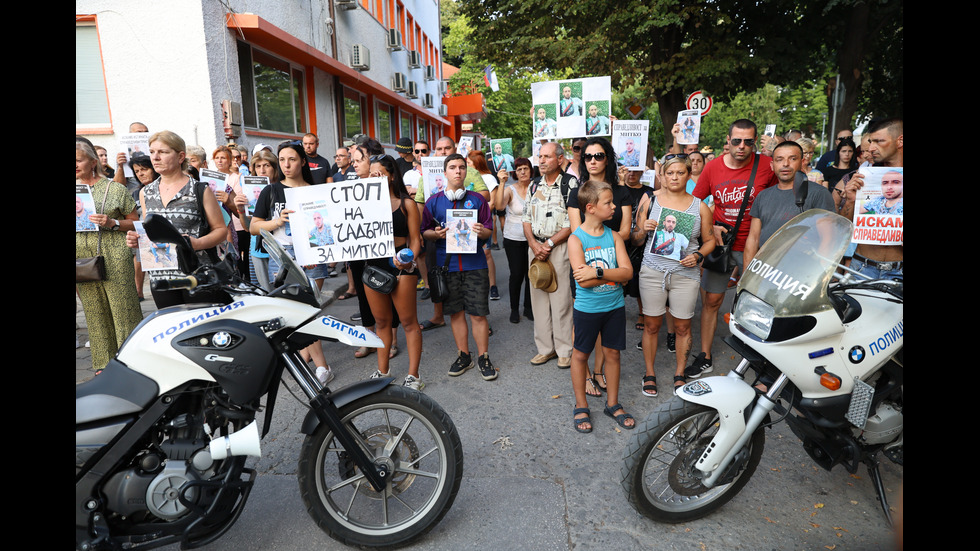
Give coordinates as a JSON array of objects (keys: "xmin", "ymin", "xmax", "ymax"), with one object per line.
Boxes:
[{"xmin": 568, "ymin": 181, "xmax": 636, "ymax": 432}]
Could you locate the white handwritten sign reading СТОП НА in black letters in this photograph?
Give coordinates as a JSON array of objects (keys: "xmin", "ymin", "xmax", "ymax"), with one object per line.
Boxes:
[{"xmin": 285, "ymin": 178, "xmax": 395, "ymax": 265}]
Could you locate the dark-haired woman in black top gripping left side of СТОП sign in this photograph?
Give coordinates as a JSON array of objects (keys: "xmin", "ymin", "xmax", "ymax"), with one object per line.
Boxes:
[{"xmin": 248, "ymin": 143, "xmax": 333, "ymax": 384}]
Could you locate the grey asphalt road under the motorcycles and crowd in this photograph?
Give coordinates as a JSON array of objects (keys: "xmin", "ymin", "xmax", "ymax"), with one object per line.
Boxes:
[{"xmin": 76, "ymin": 250, "xmax": 903, "ymax": 551}]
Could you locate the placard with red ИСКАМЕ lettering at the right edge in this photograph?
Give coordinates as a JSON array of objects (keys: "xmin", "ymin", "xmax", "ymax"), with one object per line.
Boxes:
[{"xmin": 851, "ymin": 167, "xmax": 905, "ymax": 245}]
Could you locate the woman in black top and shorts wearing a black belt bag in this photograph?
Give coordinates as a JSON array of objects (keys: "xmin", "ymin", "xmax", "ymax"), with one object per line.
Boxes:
[{"xmin": 364, "ymin": 155, "xmax": 425, "ymax": 390}]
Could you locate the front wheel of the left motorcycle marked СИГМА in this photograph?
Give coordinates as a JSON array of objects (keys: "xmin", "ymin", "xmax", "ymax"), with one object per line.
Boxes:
[{"xmin": 299, "ymin": 386, "xmax": 463, "ymax": 547}]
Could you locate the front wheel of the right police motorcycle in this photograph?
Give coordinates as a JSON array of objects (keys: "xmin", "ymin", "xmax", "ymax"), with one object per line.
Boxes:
[{"xmin": 621, "ymin": 397, "xmax": 765, "ymax": 523}]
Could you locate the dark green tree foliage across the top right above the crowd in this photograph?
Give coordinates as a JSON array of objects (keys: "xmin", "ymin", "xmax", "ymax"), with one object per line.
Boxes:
[{"xmin": 455, "ymin": 0, "xmax": 903, "ymax": 147}]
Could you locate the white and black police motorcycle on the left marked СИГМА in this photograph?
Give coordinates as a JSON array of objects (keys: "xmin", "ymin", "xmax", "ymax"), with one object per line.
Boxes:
[{"xmin": 75, "ymin": 215, "xmax": 463, "ymax": 550}]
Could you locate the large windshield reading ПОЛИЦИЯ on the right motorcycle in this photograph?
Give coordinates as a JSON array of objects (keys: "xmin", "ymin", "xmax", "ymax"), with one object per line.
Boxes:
[{"xmin": 738, "ymin": 209, "xmax": 851, "ymax": 317}]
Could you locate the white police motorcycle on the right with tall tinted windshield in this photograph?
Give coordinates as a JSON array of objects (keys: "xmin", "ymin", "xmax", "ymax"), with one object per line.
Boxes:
[{"xmin": 621, "ymin": 210, "xmax": 904, "ymax": 523}]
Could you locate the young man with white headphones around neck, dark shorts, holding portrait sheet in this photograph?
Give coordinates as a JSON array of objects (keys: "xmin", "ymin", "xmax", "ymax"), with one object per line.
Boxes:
[{"xmin": 422, "ymin": 153, "xmax": 497, "ymax": 381}]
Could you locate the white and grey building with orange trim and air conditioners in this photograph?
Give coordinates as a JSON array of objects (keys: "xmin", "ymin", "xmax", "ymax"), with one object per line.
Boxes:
[{"xmin": 75, "ymin": 0, "xmax": 453, "ymax": 162}]
